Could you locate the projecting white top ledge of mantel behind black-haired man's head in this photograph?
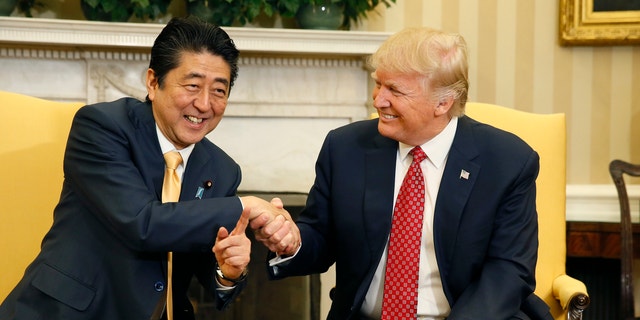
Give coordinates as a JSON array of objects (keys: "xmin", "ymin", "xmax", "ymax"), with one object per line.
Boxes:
[{"xmin": 0, "ymin": 17, "xmax": 389, "ymax": 56}]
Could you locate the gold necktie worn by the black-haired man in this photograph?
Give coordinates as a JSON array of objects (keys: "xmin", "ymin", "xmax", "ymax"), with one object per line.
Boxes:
[{"xmin": 162, "ymin": 151, "xmax": 182, "ymax": 320}]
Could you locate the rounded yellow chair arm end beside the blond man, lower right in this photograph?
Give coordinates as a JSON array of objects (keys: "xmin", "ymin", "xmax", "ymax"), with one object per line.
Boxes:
[{"xmin": 553, "ymin": 274, "xmax": 590, "ymax": 319}]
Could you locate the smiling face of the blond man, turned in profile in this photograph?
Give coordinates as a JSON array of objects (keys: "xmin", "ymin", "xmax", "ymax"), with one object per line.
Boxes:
[{"xmin": 372, "ymin": 69, "xmax": 453, "ymax": 146}]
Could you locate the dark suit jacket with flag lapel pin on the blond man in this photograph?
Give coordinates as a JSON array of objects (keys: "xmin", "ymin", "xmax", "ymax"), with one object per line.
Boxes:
[{"xmin": 270, "ymin": 116, "xmax": 550, "ymax": 320}]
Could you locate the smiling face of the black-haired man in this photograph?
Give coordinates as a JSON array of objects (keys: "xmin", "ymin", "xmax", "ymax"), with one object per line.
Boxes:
[{"xmin": 146, "ymin": 52, "xmax": 231, "ymax": 150}]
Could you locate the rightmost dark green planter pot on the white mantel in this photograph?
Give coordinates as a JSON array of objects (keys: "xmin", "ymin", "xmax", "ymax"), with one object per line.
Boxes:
[{"xmin": 296, "ymin": 1, "xmax": 344, "ymax": 30}]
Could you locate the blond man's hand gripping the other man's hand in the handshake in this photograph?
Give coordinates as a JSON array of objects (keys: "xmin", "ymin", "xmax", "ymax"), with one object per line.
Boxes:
[{"xmin": 251, "ymin": 198, "xmax": 300, "ymax": 256}]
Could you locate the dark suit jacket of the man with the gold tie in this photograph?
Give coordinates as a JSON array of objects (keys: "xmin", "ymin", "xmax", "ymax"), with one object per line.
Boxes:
[{"xmin": 0, "ymin": 98, "xmax": 242, "ymax": 320}]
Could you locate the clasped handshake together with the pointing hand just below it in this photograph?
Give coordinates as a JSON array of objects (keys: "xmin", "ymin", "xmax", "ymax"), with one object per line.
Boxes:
[{"xmin": 212, "ymin": 196, "xmax": 300, "ymax": 286}]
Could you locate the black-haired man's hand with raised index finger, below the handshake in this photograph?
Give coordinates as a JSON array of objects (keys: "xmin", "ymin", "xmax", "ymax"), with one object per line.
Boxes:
[{"xmin": 211, "ymin": 208, "xmax": 251, "ymax": 286}]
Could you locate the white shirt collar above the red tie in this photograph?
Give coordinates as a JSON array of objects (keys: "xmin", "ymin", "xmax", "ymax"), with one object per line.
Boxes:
[{"xmin": 398, "ymin": 117, "xmax": 458, "ymax": 168}]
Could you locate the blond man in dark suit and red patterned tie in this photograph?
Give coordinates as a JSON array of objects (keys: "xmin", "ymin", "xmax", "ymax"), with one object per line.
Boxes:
[{"xmin": 261, "ymin": 28, "xmax": 550, "ymax": 320}]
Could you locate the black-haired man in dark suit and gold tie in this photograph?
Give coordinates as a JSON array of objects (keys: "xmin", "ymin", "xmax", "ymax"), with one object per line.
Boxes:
[{"xmin": 0, "ymin": 19, "xmax": 297, "ymax": 320}]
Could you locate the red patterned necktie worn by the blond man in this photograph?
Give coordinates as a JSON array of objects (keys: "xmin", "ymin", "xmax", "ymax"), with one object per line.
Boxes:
[{"xmin": 382, "ymin": 146, "xmax": 427, "ymax": 320}]
